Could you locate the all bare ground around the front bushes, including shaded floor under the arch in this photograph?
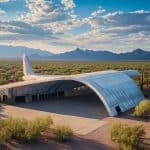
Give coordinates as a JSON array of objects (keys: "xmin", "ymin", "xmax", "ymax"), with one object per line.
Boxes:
[{"xmin": 0, "ymin": 94, "xmax": 150, "ymax": 150}]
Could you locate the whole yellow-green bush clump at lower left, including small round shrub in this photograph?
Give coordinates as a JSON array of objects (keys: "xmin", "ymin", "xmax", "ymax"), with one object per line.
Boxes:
[{"xmin": 0, "ymin": 116, "xmax": 73, "ymax": 149}]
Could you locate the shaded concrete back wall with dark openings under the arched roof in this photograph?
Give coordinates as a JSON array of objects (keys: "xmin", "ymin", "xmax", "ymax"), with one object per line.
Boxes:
[{"xmin": 0, "ymin": 81, "xmax": 92, "ymax": 103}]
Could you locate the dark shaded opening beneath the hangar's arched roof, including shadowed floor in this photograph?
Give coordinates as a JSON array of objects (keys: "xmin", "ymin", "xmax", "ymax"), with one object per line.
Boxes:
[{"xmin": 17, "ymin": 80, "xmax": 108, "ymax": 119}]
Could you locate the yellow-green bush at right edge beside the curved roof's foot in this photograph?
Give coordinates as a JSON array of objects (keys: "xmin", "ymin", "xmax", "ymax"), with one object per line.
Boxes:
[{"xmin": 134, "ymin": 100, "xmax": 150, "ymax": 117}]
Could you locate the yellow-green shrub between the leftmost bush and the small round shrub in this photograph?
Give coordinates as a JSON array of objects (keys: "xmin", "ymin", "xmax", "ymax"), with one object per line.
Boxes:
[{"xmin": 24, "ymin": 117, "xmax": 53, "ymax": 142}]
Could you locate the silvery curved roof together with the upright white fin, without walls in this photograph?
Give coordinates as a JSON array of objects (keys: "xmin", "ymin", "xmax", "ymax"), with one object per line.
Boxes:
[{"xmin": 20, "ymin": 56, "xmax": 144, "ymax": 116}]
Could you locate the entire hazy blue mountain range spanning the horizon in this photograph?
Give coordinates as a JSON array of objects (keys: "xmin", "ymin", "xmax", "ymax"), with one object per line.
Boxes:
[{"xmin": 0, "ymin": 45, "xmax": 150, "ymax": 61}]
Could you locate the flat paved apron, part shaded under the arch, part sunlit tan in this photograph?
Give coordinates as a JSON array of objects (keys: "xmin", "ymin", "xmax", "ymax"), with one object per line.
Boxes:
[{"xmin": 0, "ymin": 94, "xmax": 108, "ymax": 135}]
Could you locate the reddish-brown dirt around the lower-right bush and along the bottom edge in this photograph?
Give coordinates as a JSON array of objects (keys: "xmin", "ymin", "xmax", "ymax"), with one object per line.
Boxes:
[{"xmin": 4, "ymin": 112, "xmax": 150, "ymax": 150}]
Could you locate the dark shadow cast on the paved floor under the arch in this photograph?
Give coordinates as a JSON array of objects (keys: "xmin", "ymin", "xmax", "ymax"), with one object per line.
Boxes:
[{"xmin": 16, "ymin": 95, "xmax": 108, "ymax": 119}]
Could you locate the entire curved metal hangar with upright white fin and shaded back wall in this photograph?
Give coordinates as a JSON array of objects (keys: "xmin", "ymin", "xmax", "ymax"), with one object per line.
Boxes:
[{"xmin": 1, "ymin": 56, "xmax": 144, "ymax": 116}]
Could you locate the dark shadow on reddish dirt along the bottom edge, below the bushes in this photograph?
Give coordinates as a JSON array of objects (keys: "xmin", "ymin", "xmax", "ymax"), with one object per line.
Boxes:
[{"xmin": 6, "ymin": 136, "xmax": 114, "ymax": 150}]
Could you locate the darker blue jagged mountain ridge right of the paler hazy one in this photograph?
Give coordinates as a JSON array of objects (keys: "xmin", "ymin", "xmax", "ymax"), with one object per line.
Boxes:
[{"xmin": 50, "ymin": 48, "xmax": 150, "ymax": 61}]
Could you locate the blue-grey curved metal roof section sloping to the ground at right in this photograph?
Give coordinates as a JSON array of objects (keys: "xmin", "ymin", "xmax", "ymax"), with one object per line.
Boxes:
[{"xmin": 74, "ymin": 71, "xmax": 144, "ymax": 116}]
